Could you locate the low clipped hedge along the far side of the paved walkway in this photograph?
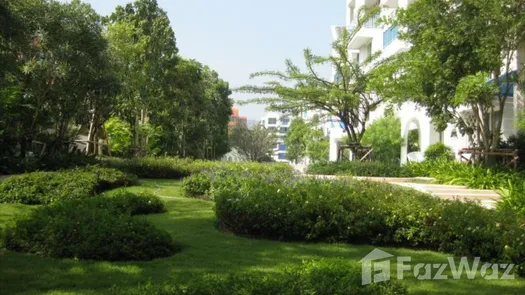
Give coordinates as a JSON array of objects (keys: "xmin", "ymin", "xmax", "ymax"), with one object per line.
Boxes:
[{"xmin": 308, "ymin": 161, "xmax": 412, "ymax": 177}]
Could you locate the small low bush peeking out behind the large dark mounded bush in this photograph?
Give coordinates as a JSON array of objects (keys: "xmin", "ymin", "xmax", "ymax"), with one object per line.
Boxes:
[{"xmin": 92, "ymin": 189, "xmax": 166, "ymax": 215}]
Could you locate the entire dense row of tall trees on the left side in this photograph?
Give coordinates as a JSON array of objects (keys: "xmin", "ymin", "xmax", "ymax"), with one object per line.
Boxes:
[{"xmin": 0, "ymin": 0, "xmax": 232, "ymax": 169}]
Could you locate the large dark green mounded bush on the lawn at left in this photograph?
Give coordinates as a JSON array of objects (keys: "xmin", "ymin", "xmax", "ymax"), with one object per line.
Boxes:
[{"xmin": 2, "ymin": 200, "xmax": 176, "ymax": 261}]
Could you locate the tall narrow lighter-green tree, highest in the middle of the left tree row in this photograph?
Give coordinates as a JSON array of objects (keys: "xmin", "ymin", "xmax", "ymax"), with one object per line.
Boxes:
[{"xmin": 108, "ymin": 0, "xmax": 178, "ymax": 154}]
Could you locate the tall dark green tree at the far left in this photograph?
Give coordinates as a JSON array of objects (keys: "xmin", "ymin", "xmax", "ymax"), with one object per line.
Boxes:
[{"xmin": 3, "ymin": 0, "xmax": 112, "ymax": 157}]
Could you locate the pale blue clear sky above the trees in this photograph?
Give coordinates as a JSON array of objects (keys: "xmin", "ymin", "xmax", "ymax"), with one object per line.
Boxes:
[{"xmin": 74, "ymin": 0, "xmax": 346, "ymax": 120}]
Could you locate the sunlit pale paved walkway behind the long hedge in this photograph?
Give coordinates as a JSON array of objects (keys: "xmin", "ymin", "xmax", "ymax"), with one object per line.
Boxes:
[{"xmin": 315, "ymin": 175, "xmax": 501, "ymax": 209}]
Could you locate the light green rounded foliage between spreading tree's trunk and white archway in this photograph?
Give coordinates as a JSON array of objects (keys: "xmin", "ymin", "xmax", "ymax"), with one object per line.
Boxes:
[{"xmin": 362, "ymin": 116, "xmax": 403, "ymax": 163}]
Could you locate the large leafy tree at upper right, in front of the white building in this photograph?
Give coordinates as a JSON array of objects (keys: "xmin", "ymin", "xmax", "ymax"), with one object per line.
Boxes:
[{"xmin": 374, "ymin": 0, "xmax": 525, "ymax": 150}]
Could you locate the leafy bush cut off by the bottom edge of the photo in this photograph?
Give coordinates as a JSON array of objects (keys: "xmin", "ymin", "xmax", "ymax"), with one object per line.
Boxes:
[{"xmin": 111, "ymin": 260, "xmax": 407, "ymax": 295}]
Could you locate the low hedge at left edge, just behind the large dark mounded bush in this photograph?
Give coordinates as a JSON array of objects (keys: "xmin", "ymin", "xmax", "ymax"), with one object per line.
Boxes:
[{"xmin": 0, "ymin": 166, "xmax": 137, "ymax": 205}]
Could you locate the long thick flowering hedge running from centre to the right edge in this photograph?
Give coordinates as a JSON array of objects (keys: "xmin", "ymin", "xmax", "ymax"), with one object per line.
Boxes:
[{"xmin": 213, "ymin": 175, "xmax": 525, "ymax": 274}]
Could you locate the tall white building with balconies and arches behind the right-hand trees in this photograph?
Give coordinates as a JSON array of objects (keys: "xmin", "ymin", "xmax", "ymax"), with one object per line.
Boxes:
[{"xmin": 330, "ymin": 0, "xmax": 525, "ymax": 163}]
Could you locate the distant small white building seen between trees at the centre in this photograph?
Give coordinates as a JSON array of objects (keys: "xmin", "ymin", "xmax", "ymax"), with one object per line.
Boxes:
[{"xmin": 261, "ymin": 112, "xmax": 291, "ymax": 162}]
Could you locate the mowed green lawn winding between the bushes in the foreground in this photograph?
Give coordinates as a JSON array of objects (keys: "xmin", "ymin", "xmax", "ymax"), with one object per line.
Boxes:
[{"xmin": 0, "ymin": 180, "xmax": 525, "ymax": 295}]
